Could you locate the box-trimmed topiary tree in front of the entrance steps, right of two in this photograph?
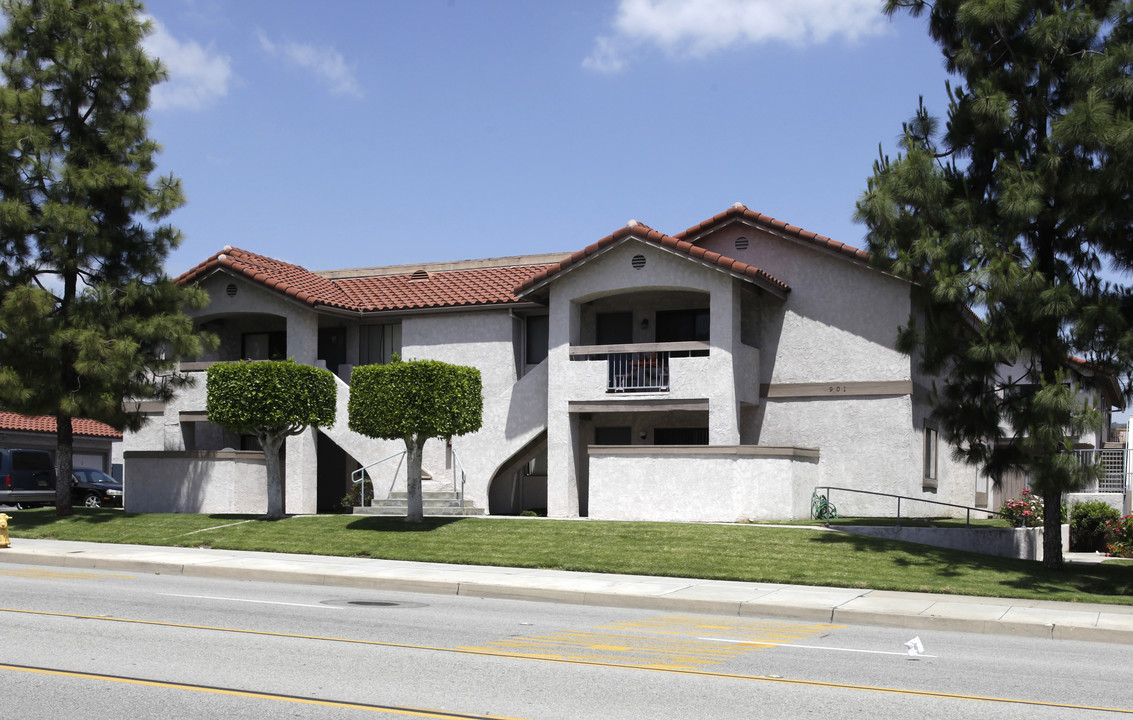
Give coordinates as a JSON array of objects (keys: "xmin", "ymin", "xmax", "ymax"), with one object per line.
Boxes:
[{"xmin": 348, "ymin": 357, "xmax": 484, "ymax": 523}]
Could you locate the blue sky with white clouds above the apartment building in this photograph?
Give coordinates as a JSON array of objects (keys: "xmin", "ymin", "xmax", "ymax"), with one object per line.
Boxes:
[{"xmin": 146, "ymin": 0, "xmax": 946, "ymax": 274}]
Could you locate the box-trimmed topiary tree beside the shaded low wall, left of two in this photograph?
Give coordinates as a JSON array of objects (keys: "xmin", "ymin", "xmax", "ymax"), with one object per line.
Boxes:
[{"xmin": 205, "ymin": 359, "xmax": 338, "ymax": 517}]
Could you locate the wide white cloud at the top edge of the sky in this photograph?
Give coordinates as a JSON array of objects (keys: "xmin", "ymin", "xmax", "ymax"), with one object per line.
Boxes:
[{"xmin": 582, "ymin": 0, "xmax": 885, "ymax": 73}]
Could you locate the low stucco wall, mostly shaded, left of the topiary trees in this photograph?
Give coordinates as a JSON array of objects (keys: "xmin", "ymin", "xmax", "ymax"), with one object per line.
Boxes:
[{"xmin": 123, "ymin": 450, "xmax": 269, "ymax": 515}]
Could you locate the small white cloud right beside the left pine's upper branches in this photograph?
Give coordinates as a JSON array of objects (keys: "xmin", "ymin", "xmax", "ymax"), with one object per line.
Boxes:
[{"xmin": 143, "ymin": 17, "xmax": 232, "ymax": 110}]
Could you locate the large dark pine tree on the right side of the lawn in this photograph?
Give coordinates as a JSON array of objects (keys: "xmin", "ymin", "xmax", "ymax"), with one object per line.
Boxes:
[{"xmin": 858, "ymin": 0, "xmax": 1133, "ymax": 568}]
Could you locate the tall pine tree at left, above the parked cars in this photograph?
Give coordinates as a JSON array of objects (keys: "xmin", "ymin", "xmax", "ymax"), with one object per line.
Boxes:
[{"xmin": 0, "ymin": 0, "xmax": 211, "ymax": 515}]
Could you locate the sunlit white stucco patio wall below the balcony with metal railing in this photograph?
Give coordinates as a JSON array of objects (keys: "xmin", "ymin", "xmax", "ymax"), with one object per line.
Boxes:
[{"xmin": 589, "ymin": 446, "xmax": 818, "ymax": 523}]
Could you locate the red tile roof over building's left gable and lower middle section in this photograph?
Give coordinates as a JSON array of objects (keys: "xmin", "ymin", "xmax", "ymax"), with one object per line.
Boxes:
[{"xmin": 177, "ymin": 247, "xmax": 557, "ymax": 312}]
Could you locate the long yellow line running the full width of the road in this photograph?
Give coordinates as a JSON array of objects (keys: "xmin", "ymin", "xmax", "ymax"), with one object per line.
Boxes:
[{"xmin": 0, "ymin": 608, "xmax": 1133, "ymax": 714}]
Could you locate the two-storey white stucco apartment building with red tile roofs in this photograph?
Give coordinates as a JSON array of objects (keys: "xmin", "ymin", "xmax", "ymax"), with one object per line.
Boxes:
[{"xmin": 125, "ymin": 204, "xmax": 1123, "ymax": 522}]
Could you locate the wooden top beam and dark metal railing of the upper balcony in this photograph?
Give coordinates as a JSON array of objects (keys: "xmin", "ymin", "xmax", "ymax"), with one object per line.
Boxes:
[{"xmin": 570, "ymin": 341, "xmax": 708, "ymax": 393}]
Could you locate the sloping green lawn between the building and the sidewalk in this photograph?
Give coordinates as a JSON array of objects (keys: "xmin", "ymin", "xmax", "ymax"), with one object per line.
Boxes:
[{"xmin": 0, "ymin": 508, "xmax": 1133, "ymax": 604}]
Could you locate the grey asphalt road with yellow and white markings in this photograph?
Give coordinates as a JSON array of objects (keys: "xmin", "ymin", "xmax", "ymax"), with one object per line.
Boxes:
[{"xmin": 0, "ymin": 565, "xmax": 1133, "ymax": 720}]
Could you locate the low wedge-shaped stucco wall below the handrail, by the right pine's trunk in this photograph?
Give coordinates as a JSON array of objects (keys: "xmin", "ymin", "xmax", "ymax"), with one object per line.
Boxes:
[{"xmin": 833, "ymin": 525, "xmax": 1070, "ymax": 560}]
